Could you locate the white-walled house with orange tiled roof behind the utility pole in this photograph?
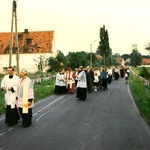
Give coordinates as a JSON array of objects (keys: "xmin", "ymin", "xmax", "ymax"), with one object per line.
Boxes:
[{"xmin": 0, "ymin": 29, "xmax": 57, "ymax": 73}]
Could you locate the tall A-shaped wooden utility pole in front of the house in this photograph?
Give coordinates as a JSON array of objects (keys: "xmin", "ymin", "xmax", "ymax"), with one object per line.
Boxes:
[{"xmin": 9, "ymin": 0, "xmax": 19, "ymax": 74}]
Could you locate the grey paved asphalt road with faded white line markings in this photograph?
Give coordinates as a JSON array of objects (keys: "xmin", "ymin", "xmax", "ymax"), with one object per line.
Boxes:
[{"xmin": 0, "ymin": 79, "xmax": 150, "ymax": 150}]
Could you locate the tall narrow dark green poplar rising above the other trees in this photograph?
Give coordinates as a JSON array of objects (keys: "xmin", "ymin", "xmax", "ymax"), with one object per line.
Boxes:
[{"xmin": 96, "ymin": 25, "xmax": 112, "ymax": 65}]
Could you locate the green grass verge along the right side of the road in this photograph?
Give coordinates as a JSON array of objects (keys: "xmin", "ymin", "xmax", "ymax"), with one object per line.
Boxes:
[{"xmin": 130, "ymin": 73, "xmax": 150, "ymax": 125}]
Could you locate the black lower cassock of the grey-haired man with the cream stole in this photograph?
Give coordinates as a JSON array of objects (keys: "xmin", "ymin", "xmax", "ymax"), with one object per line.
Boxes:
[{"xmin": 19, "ymin": 107, "xmax": 32, "ymax": 127}]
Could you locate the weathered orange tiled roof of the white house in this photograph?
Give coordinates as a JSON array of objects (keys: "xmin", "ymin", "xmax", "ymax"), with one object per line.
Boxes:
[{"xmin": 0, "ymin": 29, "xmax": 54, "ymax": 54}]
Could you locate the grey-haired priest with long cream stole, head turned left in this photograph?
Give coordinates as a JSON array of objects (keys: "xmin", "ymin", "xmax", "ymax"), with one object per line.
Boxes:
[{"xmin": 18, "ymin": 69, "xmax": 34, "ymax": 127}]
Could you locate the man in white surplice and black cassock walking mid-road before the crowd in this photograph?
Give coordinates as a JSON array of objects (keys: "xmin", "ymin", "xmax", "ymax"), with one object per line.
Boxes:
[{"xmin": 76, "ymin": 66, "xmax": 87, "ymax": 101}]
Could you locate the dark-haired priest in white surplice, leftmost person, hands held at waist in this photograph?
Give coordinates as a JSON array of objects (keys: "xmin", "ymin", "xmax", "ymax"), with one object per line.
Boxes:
[{"xmin": 1, "ymin": 66, "xmax": 20, "ymax": 126}]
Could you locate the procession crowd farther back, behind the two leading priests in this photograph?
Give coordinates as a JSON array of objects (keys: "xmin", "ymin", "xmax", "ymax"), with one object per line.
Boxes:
[{"xmin": 55, "ymin": 66, "xmax": 130, "ymax": 101}]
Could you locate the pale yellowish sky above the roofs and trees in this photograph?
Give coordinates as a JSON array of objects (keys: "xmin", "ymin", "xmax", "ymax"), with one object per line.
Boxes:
[{"xmin": 0, "ymin": 0, "xmax": 150, "ymax": 55}]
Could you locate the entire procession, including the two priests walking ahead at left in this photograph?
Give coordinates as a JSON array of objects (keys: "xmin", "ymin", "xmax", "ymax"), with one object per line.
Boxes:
[{"xmin": 1, "ymin": 66, "xmax": 130, "ymax": 127}]
